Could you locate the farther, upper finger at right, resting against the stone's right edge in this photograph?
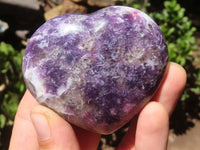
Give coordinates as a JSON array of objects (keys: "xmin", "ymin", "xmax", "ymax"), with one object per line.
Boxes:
[{"xmin": 153, "ymin": 62, "xmax": 186, "ymax": 114}]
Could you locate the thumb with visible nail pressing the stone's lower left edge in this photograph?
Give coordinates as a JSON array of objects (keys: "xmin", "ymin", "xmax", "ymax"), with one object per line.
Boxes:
[{"xmin": 31, "ymin": 105, "xmax": 79, "ymax": 150}]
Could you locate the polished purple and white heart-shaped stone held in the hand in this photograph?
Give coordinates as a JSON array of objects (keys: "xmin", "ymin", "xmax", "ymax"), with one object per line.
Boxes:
[{"xmin": 23, "ymin": 6, "xmax": 168, "ymax": 134}]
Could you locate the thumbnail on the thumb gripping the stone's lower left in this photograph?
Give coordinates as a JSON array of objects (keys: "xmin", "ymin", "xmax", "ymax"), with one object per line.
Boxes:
[{"xmin": 31, "ymin": 113, "xmax": 50, "ymax": 141}]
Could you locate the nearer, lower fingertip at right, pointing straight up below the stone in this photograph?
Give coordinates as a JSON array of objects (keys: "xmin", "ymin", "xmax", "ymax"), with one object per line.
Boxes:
[{"xmin": 135, "ymin": 102, "xmax": 169, "ymax": 150}]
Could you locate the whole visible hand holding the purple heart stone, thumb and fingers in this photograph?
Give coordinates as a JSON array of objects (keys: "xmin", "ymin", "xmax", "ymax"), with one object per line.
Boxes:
[{"xmin": 9, "ymin": 63, "xmax": 186, "ymax": 150}]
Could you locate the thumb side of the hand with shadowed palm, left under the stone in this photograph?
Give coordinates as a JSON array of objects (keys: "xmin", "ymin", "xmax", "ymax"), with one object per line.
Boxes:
[{"xmin": 9, "ymin": 91, "xmax": 100, "ymax": 150}]
